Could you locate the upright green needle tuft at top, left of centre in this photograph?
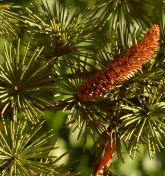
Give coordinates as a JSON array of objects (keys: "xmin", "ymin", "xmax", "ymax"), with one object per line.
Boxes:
[{"xmin": 19, "ymin": 0, "xmax": 104, "ymax": 59}]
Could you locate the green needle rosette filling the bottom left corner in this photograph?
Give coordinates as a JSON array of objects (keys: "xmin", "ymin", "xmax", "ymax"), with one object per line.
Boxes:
[{"xmin": 0, "ymin": 118, "xmax": 76, "ymax": 176}]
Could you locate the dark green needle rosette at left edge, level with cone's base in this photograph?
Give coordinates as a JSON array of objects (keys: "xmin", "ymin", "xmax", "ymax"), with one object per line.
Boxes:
[{"xmin": 0, "ymin": 41, "xmax": 57, "ymax": 123}]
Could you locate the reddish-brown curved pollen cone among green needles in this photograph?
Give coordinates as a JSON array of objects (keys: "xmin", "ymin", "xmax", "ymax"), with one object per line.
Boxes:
[{"xmin": 77, "ymin": 25, "xmax": 160, "ymax": 101}]
